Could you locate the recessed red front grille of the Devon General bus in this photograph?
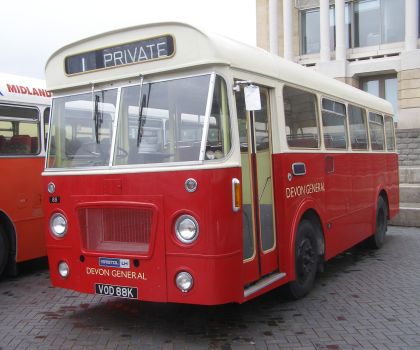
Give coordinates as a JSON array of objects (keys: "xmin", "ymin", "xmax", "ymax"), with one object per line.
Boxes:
[{"xmin": 78, "ymin": 207, "xmax": 153, "ymax": 254}]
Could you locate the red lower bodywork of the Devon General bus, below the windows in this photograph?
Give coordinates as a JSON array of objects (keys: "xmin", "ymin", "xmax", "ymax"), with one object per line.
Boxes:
[{"xmin": 44, "ymin": 154, "xmax": 398, "ymax": 305}]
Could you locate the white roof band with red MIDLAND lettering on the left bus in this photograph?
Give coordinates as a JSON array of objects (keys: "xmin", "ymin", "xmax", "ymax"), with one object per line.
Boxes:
[{"xmin": 0, "ymin": 73, "xmax": 51, "ymax": 105}]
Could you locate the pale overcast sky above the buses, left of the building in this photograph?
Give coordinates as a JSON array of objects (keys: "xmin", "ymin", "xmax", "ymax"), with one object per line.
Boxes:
[{"xmin": 0, "ymin": 0, "xmax": 256, "ymax": 79}]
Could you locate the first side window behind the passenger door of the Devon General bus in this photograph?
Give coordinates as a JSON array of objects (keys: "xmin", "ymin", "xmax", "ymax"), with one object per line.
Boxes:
[{"xmin": 283, "ymin": 86, "xmax": 319, "ymax": 148}]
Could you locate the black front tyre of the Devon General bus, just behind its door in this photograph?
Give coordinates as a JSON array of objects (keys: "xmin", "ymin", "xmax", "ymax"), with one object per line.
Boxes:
[{"xmin": 288, "ymin": 220, "xmax": 319, "ymax": 299}]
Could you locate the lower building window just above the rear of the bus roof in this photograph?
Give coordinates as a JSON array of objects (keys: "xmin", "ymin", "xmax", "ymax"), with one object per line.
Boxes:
[{"xmin": 360, "ymin": 74, "xmax": 398, "ymax": 114}]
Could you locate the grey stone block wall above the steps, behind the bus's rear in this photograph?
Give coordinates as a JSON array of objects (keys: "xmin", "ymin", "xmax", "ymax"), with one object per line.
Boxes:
[{"xmin": 397, "ymin": 129, "xmax": 420, "ymax": 166}]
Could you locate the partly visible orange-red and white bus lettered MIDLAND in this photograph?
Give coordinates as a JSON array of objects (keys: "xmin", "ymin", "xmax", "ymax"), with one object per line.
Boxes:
[{"xmin": 0, "ymin": 73, "xmax": 51, "ymax": 275}]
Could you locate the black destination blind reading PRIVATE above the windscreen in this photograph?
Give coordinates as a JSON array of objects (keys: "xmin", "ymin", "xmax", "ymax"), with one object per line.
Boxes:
[{"xmin": 65, "ymin": 35, "xmax": 175, "ymax": 75}]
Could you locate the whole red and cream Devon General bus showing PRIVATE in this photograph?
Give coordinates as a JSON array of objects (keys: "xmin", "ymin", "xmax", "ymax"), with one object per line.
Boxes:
[{"xmin": 43, "ymin": 23, "xmax": 399, "ymax": 305}]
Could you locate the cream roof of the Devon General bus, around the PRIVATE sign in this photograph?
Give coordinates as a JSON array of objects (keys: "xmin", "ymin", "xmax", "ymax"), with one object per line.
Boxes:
[{"xmin": 45, "ymin": 22, "xmax": 393, "ymax": 114}]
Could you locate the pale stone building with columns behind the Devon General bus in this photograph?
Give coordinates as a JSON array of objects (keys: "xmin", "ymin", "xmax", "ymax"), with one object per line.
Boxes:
[{"xmin": 256, "ymin": 0, "xmax": 420, "ymax": 166}]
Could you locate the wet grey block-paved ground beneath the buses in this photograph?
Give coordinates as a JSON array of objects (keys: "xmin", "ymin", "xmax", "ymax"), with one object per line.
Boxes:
[{"xmin": 0, "ymin": 227, "xmax": 420, "ymax": 350}]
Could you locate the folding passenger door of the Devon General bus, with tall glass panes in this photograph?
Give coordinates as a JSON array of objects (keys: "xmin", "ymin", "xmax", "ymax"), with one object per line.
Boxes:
[{"xmin": 236, "ymin": 87, "xmax": 278, "ymax": 284}]
